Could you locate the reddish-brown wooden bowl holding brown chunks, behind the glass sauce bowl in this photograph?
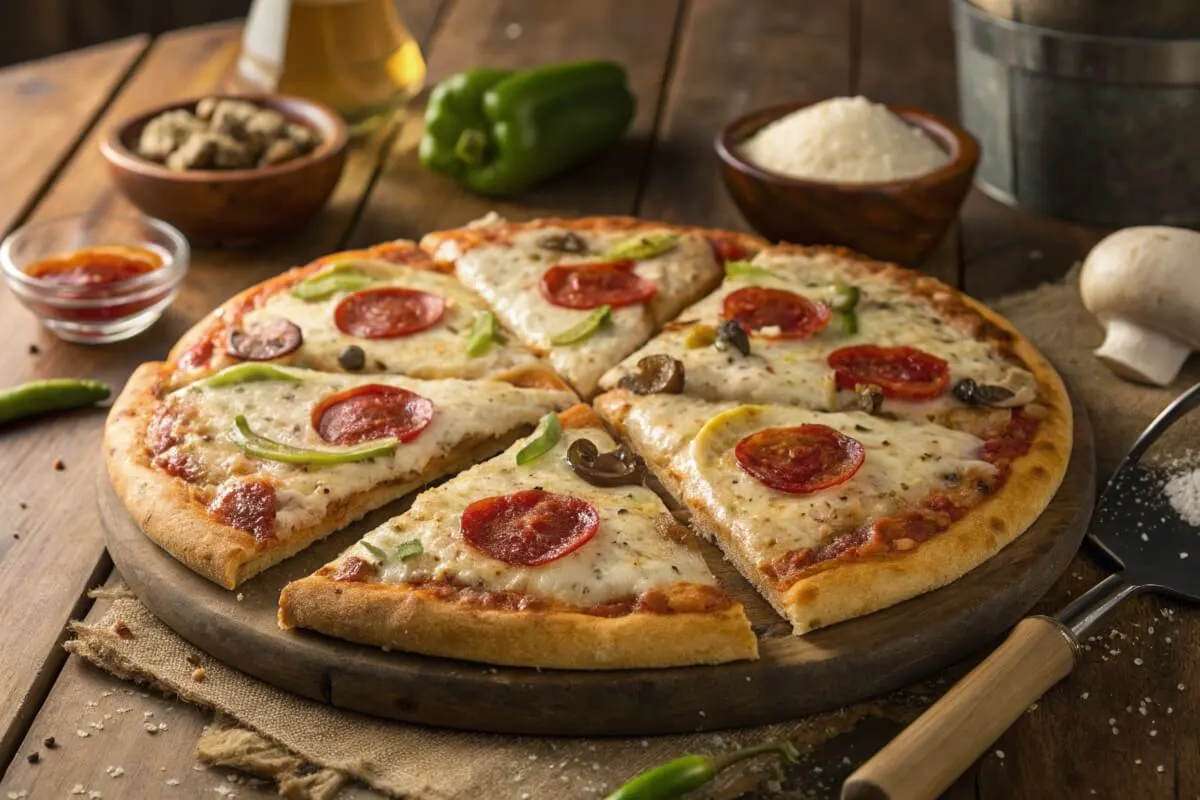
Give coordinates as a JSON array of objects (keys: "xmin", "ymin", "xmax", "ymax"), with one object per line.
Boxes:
[{"xmin": 100, "ymin": 95, "xmax": 349, "ymax": 247}]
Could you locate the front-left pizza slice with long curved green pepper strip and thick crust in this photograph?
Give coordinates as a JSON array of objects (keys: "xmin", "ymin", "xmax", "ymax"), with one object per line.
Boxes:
[{"xmin": 104, "ymin": 363, "xmax": 575, "ymax": 589}]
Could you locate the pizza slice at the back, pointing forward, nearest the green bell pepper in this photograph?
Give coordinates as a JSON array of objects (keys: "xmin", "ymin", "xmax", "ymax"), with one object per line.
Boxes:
[{"xmin": 421, "ymin": 217, "xmax": 766, "ymax": 397}]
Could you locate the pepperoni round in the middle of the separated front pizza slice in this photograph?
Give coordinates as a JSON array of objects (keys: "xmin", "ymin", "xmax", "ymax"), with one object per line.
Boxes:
[{"xmin": 461, "ymin": 489, "xmax": 600, "ymax": 566}]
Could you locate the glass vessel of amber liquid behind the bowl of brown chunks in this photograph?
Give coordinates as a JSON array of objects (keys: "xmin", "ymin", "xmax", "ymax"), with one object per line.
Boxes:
[{"xmin": 238, "ymin": 0, "xmax": 425, "ymax": 131}]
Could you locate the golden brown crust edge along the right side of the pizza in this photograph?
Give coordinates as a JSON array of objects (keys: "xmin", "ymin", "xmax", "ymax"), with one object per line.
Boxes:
[{"xmin": 595, "ymin": 292, "xmax": 1073, "ymax": 633}]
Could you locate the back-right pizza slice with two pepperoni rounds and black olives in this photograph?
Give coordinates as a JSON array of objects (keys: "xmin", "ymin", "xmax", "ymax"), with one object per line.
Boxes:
[{"xmin": 601, "ymin": 245, "xmax": 1056, "ymax": 428}]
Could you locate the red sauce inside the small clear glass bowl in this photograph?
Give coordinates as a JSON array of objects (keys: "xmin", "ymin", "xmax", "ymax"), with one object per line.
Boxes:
[{"xmin": 22, "ymin": 245, "xmax": 168, "ymax": 320}]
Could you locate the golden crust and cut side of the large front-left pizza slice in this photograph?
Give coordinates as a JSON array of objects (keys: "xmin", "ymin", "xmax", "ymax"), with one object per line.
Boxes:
[{"xmin": 104, "ymin": 362, "xmax": 535, "ymax": 589}]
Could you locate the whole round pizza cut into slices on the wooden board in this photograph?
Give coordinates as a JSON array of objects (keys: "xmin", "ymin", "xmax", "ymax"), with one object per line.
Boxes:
[{"xmin": 104, "ymin": 217, "xmax": 1072, "ymax": 669}]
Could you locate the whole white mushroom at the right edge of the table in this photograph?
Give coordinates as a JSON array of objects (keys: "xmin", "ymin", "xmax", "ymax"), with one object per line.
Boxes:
[{"xmin": 1079, "ymin": 225, "xmax": 1200, "ymax": 386}]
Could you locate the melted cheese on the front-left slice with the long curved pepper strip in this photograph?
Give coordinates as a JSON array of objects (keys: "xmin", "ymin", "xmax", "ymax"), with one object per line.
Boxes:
[{"xmin": 164, "ymin": 369, "xmax": 575, "ymax": 531}]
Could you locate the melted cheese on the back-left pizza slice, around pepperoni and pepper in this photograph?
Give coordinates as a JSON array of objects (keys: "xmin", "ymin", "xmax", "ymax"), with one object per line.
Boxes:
[{"xmin": 245, "ymin": 260, "xmax": 534, "ymax": 378}]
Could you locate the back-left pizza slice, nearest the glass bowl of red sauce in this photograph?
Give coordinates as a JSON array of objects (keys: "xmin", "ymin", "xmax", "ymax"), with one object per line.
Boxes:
[{"xmin": 169, "ymin": 241, "xmax": 535, "ymax": 384}]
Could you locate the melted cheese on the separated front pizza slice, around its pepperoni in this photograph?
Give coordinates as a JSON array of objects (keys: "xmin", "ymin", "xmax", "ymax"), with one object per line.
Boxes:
[{"xmin": 342, "ymin": 428, "xmax": 715, "ymax": 607}]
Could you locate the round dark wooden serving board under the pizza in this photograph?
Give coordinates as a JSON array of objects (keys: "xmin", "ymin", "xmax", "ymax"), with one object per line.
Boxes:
[{"xmin": 105, "ymin": 393, "xmax": 1096, "ymax": 735}]
